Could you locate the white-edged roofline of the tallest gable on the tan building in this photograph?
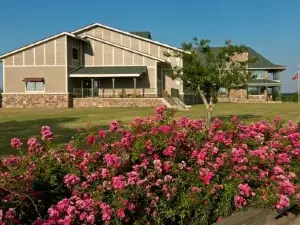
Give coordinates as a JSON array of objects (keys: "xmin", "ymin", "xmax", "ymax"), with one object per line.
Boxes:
[{"xmin": 72, "ymin": 23, "xmax": 183, "ymax": 52}]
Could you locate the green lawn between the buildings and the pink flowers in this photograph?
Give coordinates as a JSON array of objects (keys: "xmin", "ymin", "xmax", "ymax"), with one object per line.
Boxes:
[{"xmin": 0, "ymin": 103, "xmax": 300, "ymax": 155}]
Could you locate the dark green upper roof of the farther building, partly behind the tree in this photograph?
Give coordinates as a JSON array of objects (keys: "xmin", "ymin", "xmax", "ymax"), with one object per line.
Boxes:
[{"xmin": 196, "ymin": 47, "xmax": 286, "ymax": 70}]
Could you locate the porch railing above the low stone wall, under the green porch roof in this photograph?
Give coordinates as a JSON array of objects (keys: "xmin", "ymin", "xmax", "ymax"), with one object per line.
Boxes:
[{"xmin": 73, "ymin": 88, "xmax": 157, "ymax": 98}]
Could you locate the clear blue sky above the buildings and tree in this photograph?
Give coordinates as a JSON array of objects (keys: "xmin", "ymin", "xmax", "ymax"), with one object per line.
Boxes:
[{"xmin": 0, "ymin": 0, "xmax": 300, "ymax": 92}]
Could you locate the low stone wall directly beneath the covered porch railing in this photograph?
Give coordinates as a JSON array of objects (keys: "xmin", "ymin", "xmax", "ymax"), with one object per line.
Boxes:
[{"xmin": 73, "ymin": 98, "xmax": 163, "ymax": 108}]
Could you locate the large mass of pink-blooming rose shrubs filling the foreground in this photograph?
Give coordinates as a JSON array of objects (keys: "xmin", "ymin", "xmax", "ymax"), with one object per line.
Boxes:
[{"xmin": 0, "ymin": 106, "xmax": 300, "ymax": 225}]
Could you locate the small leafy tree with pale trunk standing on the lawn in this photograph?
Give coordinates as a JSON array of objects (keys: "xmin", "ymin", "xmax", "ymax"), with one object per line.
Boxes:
[{"xmin": 165, "ymin": 38, "xmax": 254, "ymax": 126}]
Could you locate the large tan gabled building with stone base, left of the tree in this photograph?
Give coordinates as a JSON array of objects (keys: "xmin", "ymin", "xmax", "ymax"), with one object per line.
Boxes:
[{"xmin": 0, "ymin": 23, "xmax": 183, "ymax": 107}]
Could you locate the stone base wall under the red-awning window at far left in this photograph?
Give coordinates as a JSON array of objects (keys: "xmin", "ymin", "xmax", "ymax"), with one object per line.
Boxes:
[{"xmin": 2, "ymin": 94, "xmax": 72, "ymax": 108}]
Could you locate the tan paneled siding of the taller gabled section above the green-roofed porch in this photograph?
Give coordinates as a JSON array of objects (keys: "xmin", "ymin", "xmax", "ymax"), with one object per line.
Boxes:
[{"xmin": 78, "ymin": 27, "xmax": 183, "ymax": 93}]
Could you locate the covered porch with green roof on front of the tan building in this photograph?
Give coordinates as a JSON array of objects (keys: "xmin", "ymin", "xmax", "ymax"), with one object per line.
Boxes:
[{"xmin": 69, "ymin": 66, "xmax": 157, "ymax": 98}]
